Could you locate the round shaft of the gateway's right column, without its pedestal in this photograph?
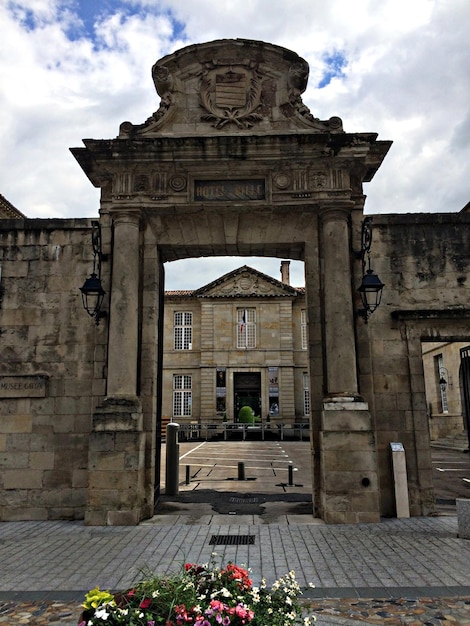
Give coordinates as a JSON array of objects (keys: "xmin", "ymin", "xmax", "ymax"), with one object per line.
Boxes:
[{"xmin": 321, "ymin": 208, "xmax": 357, "ymax": 396}]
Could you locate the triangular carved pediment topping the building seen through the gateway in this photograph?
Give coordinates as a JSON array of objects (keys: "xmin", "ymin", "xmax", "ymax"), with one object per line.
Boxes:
[{"xmin": 193, "ymin": 265, "xmax": 298, "ymax": 298}]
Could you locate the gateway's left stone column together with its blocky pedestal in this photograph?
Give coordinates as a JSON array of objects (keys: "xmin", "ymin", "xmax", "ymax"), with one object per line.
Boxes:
[{"xmin": 85, "ymin": 211, "xmax": 145, "ymax": 526}]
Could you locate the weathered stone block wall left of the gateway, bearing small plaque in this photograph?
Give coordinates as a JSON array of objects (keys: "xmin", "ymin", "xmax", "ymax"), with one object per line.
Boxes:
[{"xmin": 0, "ymin": 219, "xmax": 105, "ymax": 521}]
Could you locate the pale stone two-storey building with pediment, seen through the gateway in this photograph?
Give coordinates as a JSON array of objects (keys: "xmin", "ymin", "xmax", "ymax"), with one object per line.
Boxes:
[{"xmin": 163, "ymin": 261, "xmax": 310, "ymax": 434}]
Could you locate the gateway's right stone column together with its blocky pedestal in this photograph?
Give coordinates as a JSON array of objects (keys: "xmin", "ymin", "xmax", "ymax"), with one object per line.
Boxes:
[{"xmin": 319, "ymin": 208, "xmax": 380, "ymax": 524}]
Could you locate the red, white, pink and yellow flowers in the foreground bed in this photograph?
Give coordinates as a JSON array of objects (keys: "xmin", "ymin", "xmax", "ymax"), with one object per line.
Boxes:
[{"xmin": 79, "ymin": 563, "xmax": 315, "ymax": 626}]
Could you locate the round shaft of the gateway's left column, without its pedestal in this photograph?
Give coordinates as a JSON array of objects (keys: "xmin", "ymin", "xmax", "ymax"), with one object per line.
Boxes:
[{"xmin": 107, "ymin": 211, "xmax": 140, "ymax": 397}]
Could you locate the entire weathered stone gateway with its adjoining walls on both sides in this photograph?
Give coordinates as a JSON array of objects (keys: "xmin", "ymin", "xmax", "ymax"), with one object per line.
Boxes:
[{"xmin": 0, "ymin": 40, "xmax": 470, "ymax": 524}]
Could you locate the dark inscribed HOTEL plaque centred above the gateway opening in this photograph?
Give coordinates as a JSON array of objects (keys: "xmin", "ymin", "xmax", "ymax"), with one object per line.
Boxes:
[{"xmin": 194, "ymin": 178, "xmax": 266, "ymax": 202}]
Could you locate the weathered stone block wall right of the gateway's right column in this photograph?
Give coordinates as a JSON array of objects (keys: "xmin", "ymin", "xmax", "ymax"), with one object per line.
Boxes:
[{"xmin": 362, "ymin": 213, "xmax": 470, "ymax": 516}]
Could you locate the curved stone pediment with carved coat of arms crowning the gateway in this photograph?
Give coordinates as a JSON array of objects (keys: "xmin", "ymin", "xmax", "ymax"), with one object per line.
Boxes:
[{"xmin": 119, "ymin": 39, "xmax": 343, "ymax": 138}]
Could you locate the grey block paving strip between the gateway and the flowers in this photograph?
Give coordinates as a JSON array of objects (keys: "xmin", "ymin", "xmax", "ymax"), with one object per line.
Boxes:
[{"xmin": 0, "ymin": 517, "xmax": 470, "ymax": 597}]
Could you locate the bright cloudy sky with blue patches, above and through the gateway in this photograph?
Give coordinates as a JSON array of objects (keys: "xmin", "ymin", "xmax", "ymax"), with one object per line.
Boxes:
[{"xmin": 0, "ymin": 0, "xmax": 470, "ymax": 289}]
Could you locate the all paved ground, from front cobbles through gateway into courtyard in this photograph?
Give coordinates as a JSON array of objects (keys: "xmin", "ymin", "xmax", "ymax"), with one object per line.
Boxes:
[{"xmin": 0, "ymin": 442, "xmax": 470, "ymax": 626}]
